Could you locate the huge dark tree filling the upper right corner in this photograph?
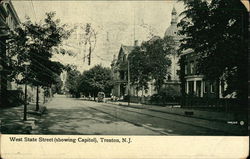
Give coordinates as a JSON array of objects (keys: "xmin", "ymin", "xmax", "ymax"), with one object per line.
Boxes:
[{"xmin": 178, "ymin": 0, "xmax": 248, "ymax": 102}]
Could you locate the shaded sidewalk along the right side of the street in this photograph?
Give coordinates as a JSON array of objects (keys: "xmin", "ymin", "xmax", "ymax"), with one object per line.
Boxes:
[{"xmin": 107, "ymin": 101, "xmax": 247, "ymax": 134}]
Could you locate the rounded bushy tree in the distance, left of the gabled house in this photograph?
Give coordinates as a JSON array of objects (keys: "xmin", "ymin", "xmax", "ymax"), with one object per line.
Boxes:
[{"xmin": 79, "ymin": 65, "xmax": 113, "ymax": 97}]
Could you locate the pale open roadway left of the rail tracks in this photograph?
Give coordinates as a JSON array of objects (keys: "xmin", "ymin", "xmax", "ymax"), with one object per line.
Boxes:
[{"xmin": 34, "ymin": 95, "xmax": 159, "ymax": 135}]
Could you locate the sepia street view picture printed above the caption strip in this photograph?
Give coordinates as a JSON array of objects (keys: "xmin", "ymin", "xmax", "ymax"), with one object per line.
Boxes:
[{"xmin": 0, "ymin": 0, "xmax": 249, "ymax": 138}]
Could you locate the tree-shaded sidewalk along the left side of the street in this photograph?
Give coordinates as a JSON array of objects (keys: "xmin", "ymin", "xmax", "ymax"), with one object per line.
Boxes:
[{"xmin": 0, "ymin": 103, "xmax": 49, "ymax": 134}]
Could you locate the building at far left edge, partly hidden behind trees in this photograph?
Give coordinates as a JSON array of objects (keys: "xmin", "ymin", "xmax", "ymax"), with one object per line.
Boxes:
[{"xmin": 0, "ymin": 0, "xmax": 44, "ymax": 106}]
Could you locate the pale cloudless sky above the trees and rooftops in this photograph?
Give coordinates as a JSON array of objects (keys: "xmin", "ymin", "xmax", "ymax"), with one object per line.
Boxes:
[{"xmin": 13, "ymin": 0, "xmax": 184, "ymax": 72}]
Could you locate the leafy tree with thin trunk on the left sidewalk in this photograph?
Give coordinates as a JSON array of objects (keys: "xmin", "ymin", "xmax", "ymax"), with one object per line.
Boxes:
[{"xmin": 9, "ymin": 12, "xmax": 72, "ymax": 110}]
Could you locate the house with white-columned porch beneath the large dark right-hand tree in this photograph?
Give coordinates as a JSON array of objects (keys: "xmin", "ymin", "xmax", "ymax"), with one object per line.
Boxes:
[{"xmin": 180, "ymin": 49, "xmax": 239, "ymax": 109}]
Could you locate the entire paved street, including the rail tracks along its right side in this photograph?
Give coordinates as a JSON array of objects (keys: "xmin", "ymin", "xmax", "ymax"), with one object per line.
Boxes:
[{"xmin": 33, "ymin": 95, "xmax": 229, "ymax": 135}]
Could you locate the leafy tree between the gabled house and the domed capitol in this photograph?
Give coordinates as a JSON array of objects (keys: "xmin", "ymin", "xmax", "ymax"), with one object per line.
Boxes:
[{"xmin": 128, "ymin": 37, "xmax": 175, "ymax": 92}]
